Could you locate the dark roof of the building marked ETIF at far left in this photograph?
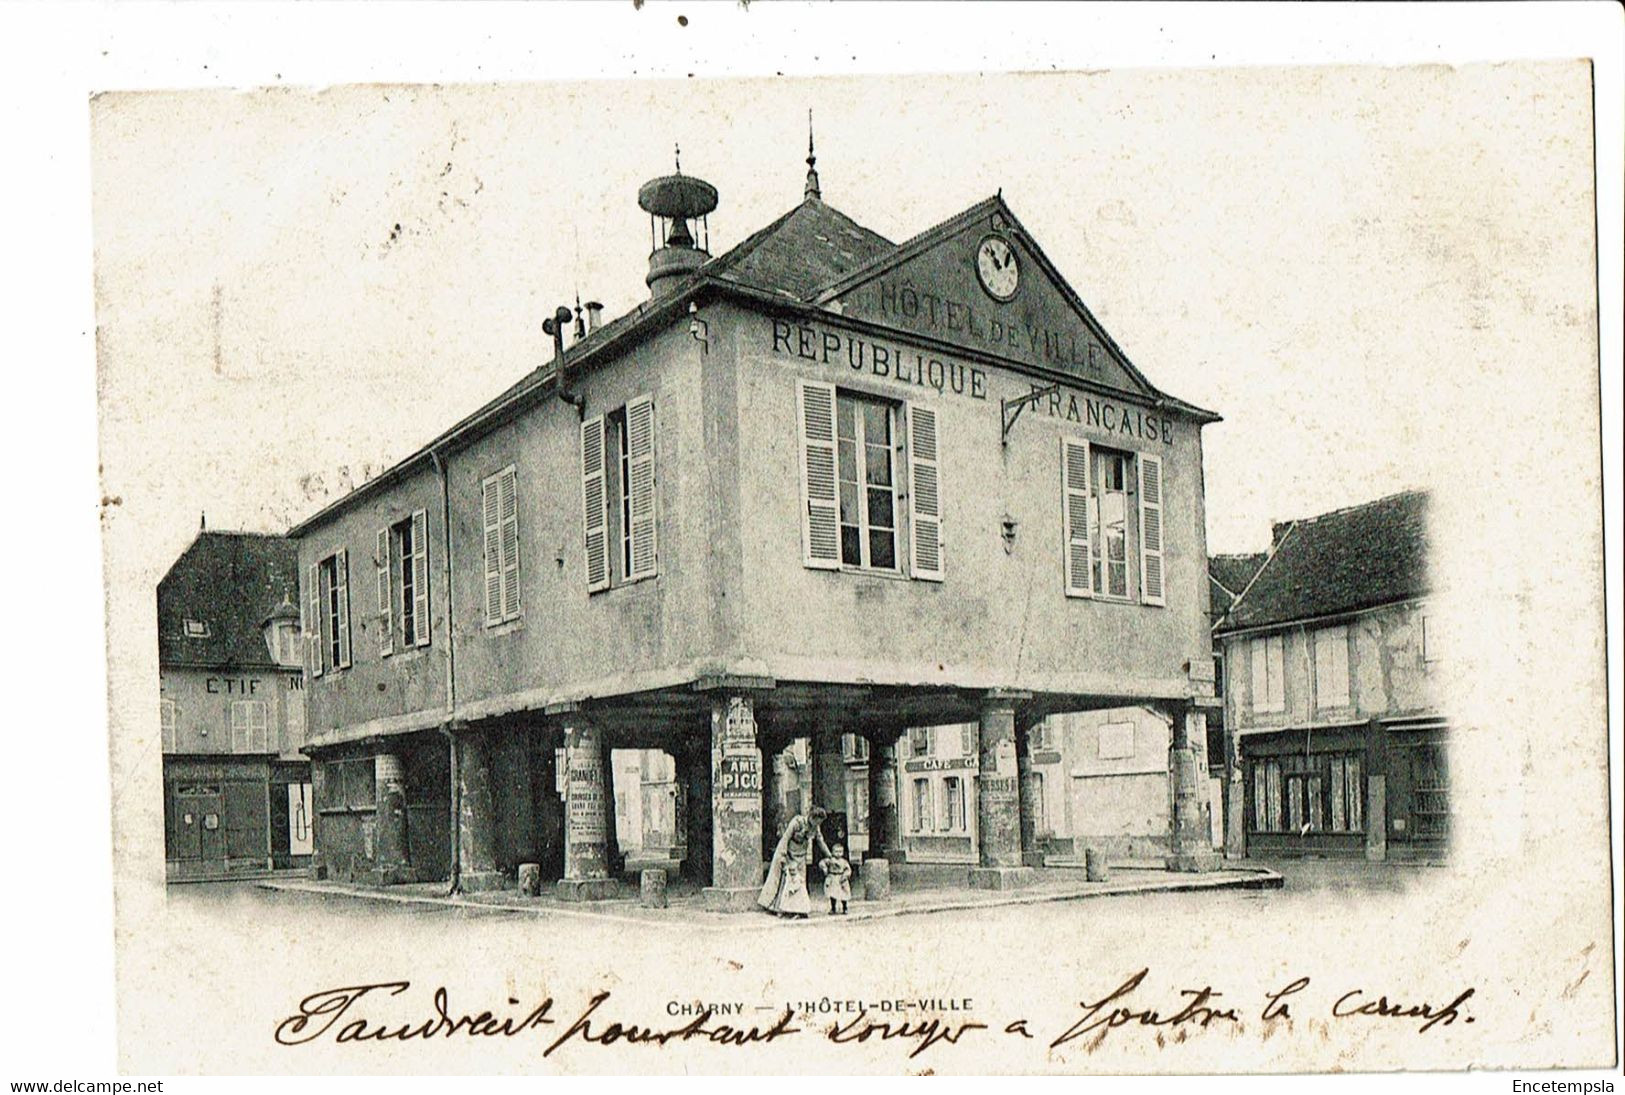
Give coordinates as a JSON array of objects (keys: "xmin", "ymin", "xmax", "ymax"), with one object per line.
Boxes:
[{"xmin": 158, "ymin": 531, "xmax": 299, "ymax": 668}]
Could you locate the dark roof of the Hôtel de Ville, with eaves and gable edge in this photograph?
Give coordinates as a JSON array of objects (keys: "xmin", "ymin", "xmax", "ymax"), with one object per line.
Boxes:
[{"xmin": 289, "ymin": 195, "xmax": 1217, "ymax": 536}]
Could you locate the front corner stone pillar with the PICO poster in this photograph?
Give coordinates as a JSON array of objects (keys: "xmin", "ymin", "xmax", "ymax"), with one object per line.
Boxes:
[{"xmin": 705, "ymin": 694, "xmax": 762, "ymax": 911}]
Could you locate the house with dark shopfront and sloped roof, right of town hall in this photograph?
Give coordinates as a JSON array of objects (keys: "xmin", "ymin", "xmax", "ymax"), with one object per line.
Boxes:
[{"xmin": 1216, "ymin": 491, "xmax": 1450, "ymax": 859}]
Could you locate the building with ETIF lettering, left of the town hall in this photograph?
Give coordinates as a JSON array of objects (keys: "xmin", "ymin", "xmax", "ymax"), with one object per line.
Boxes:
[{"xmin": 158, "ymin": 531, "xmax": 312, "ymax": 881}]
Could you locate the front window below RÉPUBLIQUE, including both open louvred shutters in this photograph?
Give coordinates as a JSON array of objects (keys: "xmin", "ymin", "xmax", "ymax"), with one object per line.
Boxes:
[{"xmin": 796, "ymin": 380, "xmax": 943, "ymax": 582}]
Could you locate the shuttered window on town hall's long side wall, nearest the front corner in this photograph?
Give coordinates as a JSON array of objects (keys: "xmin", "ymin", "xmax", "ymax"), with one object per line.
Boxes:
[{"xmin": 582, "ymin": 395, "xmax": 657, "ymax": 593}]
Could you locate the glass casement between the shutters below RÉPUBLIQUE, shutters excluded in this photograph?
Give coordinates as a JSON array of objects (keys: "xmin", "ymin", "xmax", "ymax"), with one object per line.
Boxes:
[{"xmin": 835, "ymin": 392, "xmax": 897, "ymax": 570}]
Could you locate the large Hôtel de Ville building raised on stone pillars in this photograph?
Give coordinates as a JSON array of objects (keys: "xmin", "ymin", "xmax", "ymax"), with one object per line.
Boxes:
[{"xmin": 291, "ymin": 140, "xmax": 1216, "ymax": 907}]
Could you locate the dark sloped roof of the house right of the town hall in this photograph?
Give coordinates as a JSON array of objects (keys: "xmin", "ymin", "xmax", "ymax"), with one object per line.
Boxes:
[{"xmin": 1217, "ymin": 491, "xmax": 1428, "ymax": 634}]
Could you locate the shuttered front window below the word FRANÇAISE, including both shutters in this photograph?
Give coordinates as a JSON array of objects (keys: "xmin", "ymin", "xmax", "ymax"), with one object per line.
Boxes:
[{"xmin": 1061, "ymin": 437, "xmax": 1167, "ymax": 604}]
